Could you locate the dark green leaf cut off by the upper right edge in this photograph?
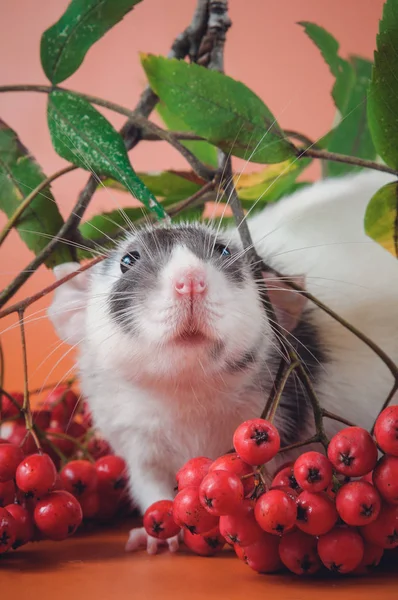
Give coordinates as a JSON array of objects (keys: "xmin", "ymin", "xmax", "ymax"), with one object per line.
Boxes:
[{"xmin": 368, "ymin": 0, "xmax": 398, "ymax": 169}]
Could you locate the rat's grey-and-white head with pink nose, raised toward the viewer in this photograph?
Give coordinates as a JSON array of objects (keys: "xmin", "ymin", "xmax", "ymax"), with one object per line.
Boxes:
[{"xmin": 49, "ymin": 224, "xmax": 308, "ymax": 379}]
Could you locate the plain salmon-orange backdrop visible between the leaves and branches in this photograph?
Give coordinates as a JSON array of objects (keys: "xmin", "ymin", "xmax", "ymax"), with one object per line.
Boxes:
[{"xmin": 0, "ymin": 0, "xmax": 383, "ymax": 391}]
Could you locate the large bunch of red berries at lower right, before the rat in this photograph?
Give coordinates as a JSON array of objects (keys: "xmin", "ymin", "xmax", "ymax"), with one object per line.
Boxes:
[{"xmin": 144, "ymin": 406, "xmax": 398, "ymax": 575}]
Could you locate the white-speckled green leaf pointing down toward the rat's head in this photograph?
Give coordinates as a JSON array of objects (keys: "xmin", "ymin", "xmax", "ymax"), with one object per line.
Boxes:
[{"xmin": 47, "ymin": 90, "xmax": 166, "ymax": 218}]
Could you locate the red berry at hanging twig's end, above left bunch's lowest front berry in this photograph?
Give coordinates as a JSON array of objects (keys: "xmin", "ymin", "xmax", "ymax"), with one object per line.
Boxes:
[{"xmin": 15, "ymin": 454, "xmax": 57, "ymax": 498}]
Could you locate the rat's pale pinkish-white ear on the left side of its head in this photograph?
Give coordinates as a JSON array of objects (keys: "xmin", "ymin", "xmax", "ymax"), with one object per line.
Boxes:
[{"xmin": 47, "ymin": 262, "xmax": 88, "ymax": 345}]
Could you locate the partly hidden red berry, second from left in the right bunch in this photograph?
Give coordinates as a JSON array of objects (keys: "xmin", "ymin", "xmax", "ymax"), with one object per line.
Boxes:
[{"xmin": 173, "ymin": 486, "xmax": 218, "ymax": 534}]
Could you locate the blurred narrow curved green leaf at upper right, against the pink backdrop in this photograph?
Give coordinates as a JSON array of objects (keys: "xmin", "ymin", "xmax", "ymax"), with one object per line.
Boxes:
[{"xmin": 298, "ymin": 21, "xmax": 355, "ymax": 114}]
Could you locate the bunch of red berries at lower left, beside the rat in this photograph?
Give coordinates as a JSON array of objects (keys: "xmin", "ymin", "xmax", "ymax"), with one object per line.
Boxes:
[{"xmin": 0, "ymin": 386, "xmax": 133, "ymax": 554}]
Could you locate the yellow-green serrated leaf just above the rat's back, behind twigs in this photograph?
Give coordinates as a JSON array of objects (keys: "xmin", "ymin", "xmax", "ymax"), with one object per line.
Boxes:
[{"xmin": 235, "ymin": 158, "xmax": 312, "ymax": 208}]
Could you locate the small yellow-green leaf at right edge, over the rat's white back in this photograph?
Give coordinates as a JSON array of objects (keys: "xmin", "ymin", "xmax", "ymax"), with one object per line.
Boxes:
[{"xmin": 365, "ymin": 181, "xmax": 398, "ymax": 258}]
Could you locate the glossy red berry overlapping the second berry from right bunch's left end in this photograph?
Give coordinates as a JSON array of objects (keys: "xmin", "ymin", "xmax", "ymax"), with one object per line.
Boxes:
[{"xmin": 199, "ymin": 471, "xmax": 244, "ymax": 517}]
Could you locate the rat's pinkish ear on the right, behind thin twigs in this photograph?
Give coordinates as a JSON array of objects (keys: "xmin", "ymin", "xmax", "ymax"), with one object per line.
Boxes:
[{"xmin": 262, "ymin": 271, "xmax": 308, "ymax": 332}]
